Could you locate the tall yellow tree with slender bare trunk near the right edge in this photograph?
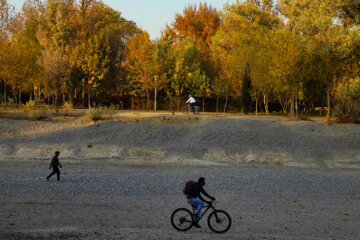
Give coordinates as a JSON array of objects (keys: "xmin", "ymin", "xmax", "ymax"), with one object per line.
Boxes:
[{"xmin": 278, "ymin": 0, "xmax": 349, "ymax": 118}]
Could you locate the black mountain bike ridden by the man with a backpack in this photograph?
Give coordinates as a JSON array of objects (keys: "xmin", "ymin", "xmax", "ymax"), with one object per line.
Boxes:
[{"xmin": 171, "ymin": 202, "xmax": 231, "ymax": 233}]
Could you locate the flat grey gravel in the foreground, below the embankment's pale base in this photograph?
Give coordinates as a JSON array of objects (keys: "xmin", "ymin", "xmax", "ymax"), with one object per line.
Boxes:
[{"xmin": 0, "ymin": 162, "xmax": 360, "ymax": 240}]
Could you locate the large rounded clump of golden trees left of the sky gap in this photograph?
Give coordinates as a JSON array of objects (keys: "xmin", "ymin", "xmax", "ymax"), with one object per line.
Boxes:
[{"xmin": 0, "ymin": 0, "xmax": 140, "ymax": 109}]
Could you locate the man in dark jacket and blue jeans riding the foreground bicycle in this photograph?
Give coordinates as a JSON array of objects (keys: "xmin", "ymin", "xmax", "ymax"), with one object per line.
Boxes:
[{"xmin": 187, "ymin": 177, "xmax": 215, "ymax": 228}]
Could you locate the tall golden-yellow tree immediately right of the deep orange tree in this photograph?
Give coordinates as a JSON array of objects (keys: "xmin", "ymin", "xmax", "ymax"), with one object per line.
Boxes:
[{"xmin": 214, "ymin": 0, "xmax": 281, "ymax": 112}]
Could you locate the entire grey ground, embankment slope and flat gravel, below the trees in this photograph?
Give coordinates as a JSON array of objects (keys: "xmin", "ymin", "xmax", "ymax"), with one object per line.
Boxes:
[{"xmin": 0, "ymin": 113, "xmax": 360, "ymax": 240}]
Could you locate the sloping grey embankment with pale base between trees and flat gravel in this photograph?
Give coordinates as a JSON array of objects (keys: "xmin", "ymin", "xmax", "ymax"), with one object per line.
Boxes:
[{"xmin": 0, "ymin": 115, "xmax": 360, "ymax": 170}]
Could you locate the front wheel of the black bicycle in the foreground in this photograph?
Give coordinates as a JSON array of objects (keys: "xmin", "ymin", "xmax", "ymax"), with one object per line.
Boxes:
[{"xmin": 208, "ymin": 210, "xmax": 231, "ymax": 233}]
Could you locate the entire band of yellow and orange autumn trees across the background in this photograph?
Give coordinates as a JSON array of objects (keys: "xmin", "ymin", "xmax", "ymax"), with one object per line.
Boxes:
[{"xmin": 0, "ymin": 0, "xmax": 360, "ymax": 120}]
